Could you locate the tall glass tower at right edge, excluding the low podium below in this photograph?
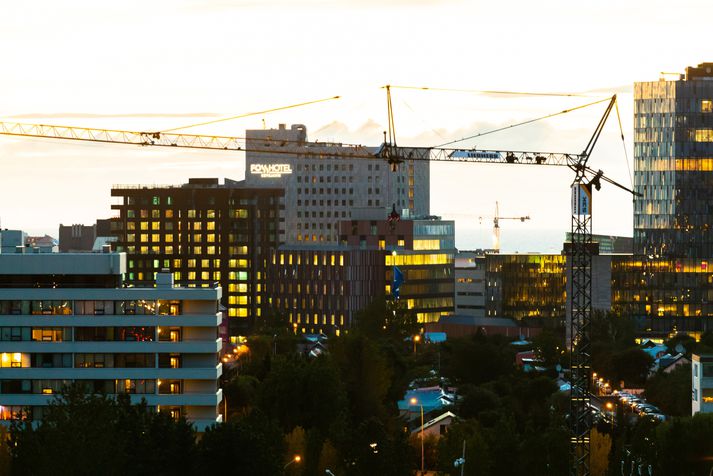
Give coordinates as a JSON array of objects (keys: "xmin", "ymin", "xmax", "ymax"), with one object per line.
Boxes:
[{"xmin": 634, "ymin": 63, "xmax": 713, "ymax": 259}]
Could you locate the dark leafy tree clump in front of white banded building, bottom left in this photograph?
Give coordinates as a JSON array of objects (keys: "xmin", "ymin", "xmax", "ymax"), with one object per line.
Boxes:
[{"xmin": 11, "ymin": 384, "xmax": 195, "ymax": 475}]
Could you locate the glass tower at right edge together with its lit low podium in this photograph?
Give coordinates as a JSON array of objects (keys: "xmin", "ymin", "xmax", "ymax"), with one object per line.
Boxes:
[{"xmin": 612, "ymin": 63, "xmax": 713, "ymax": 335}]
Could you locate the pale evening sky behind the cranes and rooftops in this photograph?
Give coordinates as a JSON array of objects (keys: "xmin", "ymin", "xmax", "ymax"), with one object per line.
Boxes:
[{"xmin": 0, "ymin": 0, "xmax": 713, "ymax": 252}]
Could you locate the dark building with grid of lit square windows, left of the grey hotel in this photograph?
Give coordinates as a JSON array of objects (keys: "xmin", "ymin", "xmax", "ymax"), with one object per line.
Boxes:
[{"xmin": 111, "ymin": 178, "xmax": 283, "ymax": 335}]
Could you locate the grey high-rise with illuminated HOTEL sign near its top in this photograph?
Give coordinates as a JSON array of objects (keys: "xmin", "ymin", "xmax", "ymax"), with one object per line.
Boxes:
[{"xmin": 245, "ymin": 124, "xmax": 430, "ymax": 245}]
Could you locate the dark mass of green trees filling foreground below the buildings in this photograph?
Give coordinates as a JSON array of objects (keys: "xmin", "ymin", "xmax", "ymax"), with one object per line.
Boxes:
[{"xmin": 11, "ymin": 303, "xmax": 713, "ymax": 476}]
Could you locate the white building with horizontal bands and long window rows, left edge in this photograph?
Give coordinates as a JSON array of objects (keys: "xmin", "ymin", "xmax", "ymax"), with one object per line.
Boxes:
[{"xmin": 0, "ymin": 250, "xmax": 222, "ymax": 431}]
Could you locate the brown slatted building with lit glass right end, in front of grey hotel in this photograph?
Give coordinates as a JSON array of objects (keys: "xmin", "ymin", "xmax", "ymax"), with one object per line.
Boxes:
[{"xmin": 266, "ymin": 216, "xmax": 455, "ymax": 334}]
